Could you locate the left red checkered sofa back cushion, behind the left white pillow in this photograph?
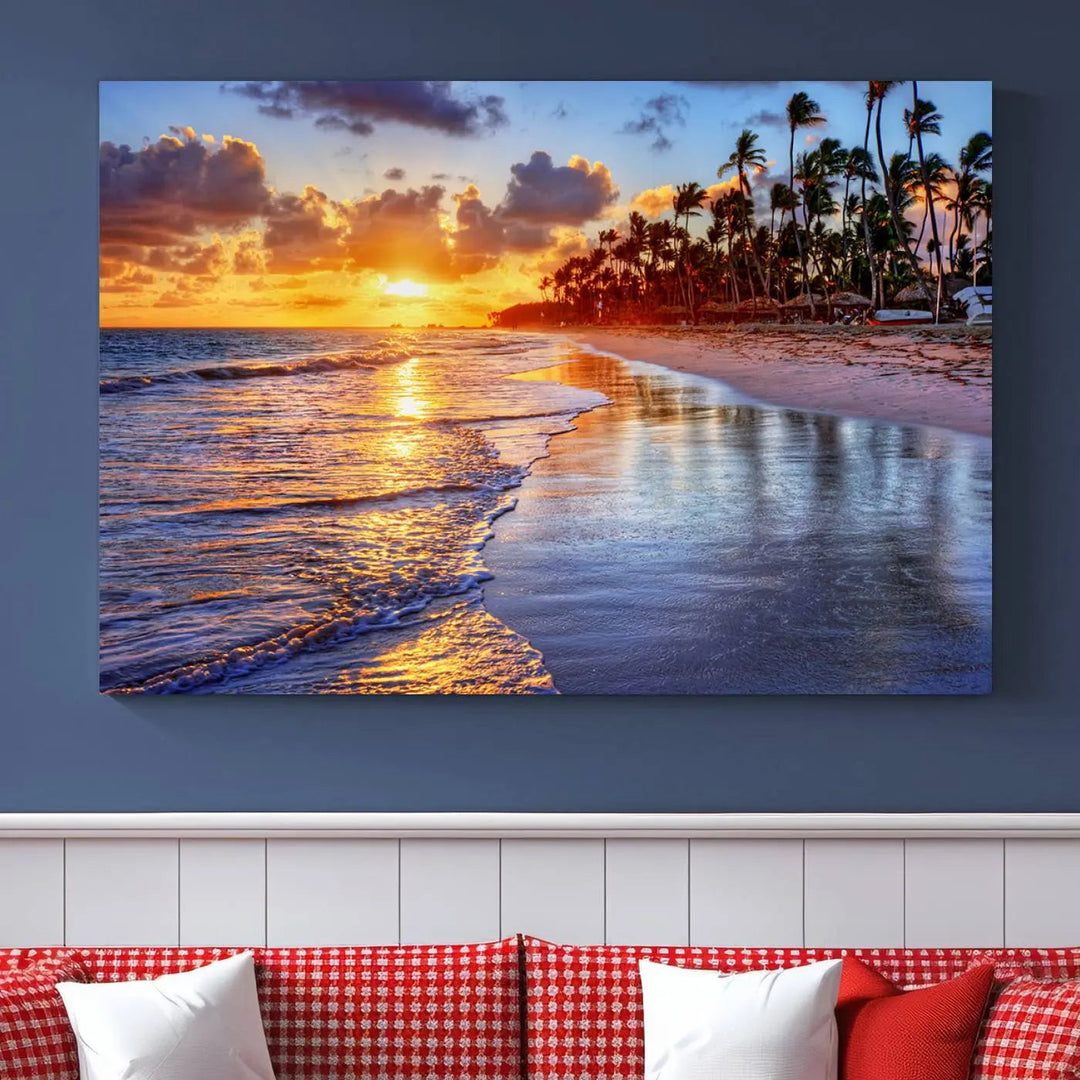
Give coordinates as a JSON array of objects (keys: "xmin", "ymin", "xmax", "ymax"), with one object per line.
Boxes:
[{"xmin": 0, "ymin": 937, "xmax": 521, "ymax": 1080}]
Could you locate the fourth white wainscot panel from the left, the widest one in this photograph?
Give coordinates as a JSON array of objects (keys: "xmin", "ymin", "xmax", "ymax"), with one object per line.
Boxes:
[{"xmin": 267, "ymin": 839, "xmax": 401, "ymax": 945}]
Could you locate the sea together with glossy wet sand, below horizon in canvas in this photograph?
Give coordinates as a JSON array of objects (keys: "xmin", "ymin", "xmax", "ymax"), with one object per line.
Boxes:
[{"xmin": 99, "ymin": 330, "xmax": 991, "ymax": 693}]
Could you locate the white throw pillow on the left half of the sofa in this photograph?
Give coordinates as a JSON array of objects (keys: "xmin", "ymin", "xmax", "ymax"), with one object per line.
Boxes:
[{"xmin": 56, "ymin": 953, "xmax": 274, "ymax": 1080}]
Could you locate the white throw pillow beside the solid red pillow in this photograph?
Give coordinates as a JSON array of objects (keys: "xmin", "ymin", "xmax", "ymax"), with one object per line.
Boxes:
[{"xmin": 638, "ymin": 960, "xmax": 842, "ymax": 1080}]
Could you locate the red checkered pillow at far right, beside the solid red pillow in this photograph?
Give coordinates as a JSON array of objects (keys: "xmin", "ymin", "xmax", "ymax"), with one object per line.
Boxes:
[{"xmin": 971, "ymin": 977, "xmax": 1080, "ymax": 1080}]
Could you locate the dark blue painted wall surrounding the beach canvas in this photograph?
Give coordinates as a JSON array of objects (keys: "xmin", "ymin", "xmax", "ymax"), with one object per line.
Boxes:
[{"xmin": 0, "ymin": 0, "xmax": 1080, "ymax": 810}]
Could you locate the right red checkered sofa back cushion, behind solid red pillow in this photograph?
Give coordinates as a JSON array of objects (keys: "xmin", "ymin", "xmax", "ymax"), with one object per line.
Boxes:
[{"xmin": 525, "ymin": 937, "xmax": 972, "ymax": 1080}]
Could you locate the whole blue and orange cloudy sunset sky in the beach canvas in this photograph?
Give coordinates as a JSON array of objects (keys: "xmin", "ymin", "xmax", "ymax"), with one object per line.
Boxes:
[{"xmin": 99, "ymin": 81, "xmax": 988, "ymax": 326}]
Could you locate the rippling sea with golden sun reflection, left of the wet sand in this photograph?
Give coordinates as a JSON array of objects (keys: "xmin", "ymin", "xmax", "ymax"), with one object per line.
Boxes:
[{"xmin": 99, "ymin": 329, "xmax": 606, "ymax": 693}]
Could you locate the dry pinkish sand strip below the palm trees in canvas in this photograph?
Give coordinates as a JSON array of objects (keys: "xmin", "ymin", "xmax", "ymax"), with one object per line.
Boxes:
[{"xmin": 549, "ymin": 325, "xmax": 993, "ymax": 437}]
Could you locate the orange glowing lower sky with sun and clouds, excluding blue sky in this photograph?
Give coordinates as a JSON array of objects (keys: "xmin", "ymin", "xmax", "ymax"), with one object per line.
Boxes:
[{"xmin": 100, "ymin": 127, "xmax": 617, "ymax": 326}]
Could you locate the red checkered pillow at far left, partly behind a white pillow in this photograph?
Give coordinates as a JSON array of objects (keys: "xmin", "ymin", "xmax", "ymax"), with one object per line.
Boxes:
[{"xmin": 0, "ymin": 956, "xmax": 90, "ymax": 1080}]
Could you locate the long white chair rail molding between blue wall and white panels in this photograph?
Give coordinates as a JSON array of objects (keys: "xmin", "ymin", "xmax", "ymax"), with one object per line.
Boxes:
[{"xmin": 0, "ymin": 812, "xmax": 1080, "ymax": 839}]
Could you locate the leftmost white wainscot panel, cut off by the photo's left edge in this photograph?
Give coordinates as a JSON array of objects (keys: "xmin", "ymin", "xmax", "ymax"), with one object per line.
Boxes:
[{"xmin": 0, "ymin": 840, "xmax": 64, "ymax": 948}]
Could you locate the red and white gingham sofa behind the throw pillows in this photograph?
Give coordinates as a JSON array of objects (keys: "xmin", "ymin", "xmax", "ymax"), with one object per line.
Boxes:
[{"xmin": 0, "ymin": 937, "xmax": 1080, "ymax": 1080}]
